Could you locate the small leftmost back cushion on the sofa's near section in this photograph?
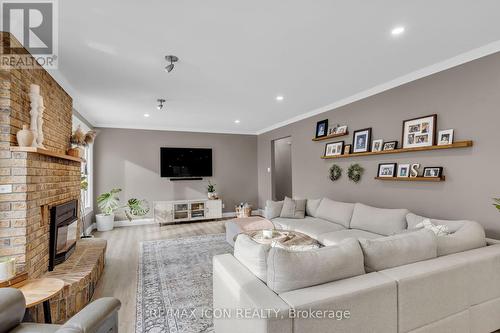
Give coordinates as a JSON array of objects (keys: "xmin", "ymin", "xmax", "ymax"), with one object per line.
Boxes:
[{"xmin": 234, "ymin": 234, "xmax": 271, "ymax": 282}]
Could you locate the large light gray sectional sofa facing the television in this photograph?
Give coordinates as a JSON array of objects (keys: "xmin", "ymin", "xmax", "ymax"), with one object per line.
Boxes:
[{"xmin": 213, "ymin": 198, "xmax": 500, "ymax": 333}]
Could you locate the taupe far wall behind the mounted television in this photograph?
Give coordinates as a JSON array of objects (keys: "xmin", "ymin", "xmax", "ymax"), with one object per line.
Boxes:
[{"xmin": 94, "ymin": 128, "xmax": 257, "ymax": 211}]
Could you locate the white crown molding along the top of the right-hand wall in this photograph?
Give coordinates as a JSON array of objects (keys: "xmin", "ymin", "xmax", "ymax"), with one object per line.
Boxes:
[{"xmin": 255, "ymin": 41, "xmax": 500, "ymax": 135}]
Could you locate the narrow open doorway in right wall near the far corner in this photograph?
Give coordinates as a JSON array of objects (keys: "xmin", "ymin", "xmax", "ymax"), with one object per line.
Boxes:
[{"xmin": 271, "ymin": 136, "xmax": 292, "ymax": 201}]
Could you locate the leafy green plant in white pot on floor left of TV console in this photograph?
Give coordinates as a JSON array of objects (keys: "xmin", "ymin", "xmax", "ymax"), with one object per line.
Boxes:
[{"xmin": 96, "ymin": 188, "xmax": 149, "ymax": 231}]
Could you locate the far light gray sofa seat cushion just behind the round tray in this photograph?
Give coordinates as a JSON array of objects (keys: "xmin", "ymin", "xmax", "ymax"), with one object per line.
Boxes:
[{"xmin": 272, "ymin": 216, "xmax": 345, "ymax": 239}]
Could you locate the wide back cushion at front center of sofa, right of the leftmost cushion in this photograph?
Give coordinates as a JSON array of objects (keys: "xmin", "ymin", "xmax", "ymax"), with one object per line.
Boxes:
[{"xmin": 267, "ymin": 239, "xmax": 365, "ymax": 293}]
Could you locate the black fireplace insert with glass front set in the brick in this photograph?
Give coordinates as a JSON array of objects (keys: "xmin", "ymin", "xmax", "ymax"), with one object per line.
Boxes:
[{"xmin": 49, "ymin": 200, "xmax": 78, "ymax": 271}]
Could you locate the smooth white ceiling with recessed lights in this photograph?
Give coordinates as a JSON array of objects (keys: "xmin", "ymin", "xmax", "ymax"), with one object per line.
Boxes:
[{"xmin": 51, "ymin": 0, "xmax": 500, "ymax": 134}]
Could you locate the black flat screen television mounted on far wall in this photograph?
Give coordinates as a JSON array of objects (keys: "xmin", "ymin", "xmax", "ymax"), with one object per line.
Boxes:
[{"xmin": 160, "ymin": 147, "xmax": 212, "ymax": 178}]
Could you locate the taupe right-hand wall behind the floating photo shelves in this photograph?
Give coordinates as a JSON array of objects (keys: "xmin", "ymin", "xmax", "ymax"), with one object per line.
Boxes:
[{"xmin": 258, "ymin": 54, "xmax": 500, "ymax": 237}]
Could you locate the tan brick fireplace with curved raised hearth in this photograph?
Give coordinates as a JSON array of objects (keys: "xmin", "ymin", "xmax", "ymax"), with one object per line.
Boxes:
[{"xmin": 0, "ymin": 32, "xmax": 106, "ymax": 323}]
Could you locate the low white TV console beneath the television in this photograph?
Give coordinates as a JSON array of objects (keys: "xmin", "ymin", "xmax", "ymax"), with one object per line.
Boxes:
[{"xmin": 153, "ymin": 199, "xmax": 222, "ymax": 224}]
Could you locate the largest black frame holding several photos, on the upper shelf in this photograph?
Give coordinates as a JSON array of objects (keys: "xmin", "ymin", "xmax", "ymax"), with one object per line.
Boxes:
[{"xmin": 402, "ymin": 114, "xmax": 437, "ymax": 148}]
